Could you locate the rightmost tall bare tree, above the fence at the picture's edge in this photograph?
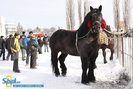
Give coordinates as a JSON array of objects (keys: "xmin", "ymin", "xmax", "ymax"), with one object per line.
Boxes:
[{"xmin": 123, "ymin": 0, "xmax": 132, "ymax": 30}]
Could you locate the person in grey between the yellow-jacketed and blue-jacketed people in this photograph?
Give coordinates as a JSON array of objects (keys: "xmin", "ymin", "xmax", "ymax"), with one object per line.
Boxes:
[{"xmin": 19, "ymin": 35, "xmax": 26, "ymax": 61}]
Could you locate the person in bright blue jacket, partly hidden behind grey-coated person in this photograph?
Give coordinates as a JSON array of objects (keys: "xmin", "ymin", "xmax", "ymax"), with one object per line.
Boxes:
[{"xmin": 24, "ymin": 31, "xmax": 38, "ymax": 66}]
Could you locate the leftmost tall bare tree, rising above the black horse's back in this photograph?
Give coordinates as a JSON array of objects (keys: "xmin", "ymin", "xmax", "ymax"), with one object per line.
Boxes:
[{"xmin": 66, "ymin": 0, "xmax": 75, "ymax": 30}]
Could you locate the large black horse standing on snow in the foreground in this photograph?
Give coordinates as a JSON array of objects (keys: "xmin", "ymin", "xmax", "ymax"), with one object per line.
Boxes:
[{"xmin": 50, "ymin": 6, "xmax": 102, "ymax": 84}]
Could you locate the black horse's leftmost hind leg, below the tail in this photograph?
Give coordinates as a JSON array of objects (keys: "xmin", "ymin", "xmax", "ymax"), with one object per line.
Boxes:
[{"xmin": 51, "ymin": 51, "xmax": 60, "ymax": 77}]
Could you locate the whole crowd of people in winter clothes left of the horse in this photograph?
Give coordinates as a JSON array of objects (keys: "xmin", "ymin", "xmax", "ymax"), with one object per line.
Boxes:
[{"xmin": 0, "ymin": 31, "xmax": 49, "ymax": 73}]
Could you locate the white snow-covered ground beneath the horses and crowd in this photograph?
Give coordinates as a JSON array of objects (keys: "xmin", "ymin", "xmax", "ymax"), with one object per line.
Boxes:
[{"xmin": 0, "ymin": 50, "xmax": 132, "ymax": 89}]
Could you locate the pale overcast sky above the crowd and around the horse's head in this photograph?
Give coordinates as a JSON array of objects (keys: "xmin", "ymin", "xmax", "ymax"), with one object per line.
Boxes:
[{"xmin": 0, "ymin": 0, "xmax": 132, "ymax": 29}]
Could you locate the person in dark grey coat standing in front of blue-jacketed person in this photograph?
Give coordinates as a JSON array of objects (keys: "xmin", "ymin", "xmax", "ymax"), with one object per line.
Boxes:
[{"xmin": 28, "ymin": 35, "xmax": 38, "ymax": 69}]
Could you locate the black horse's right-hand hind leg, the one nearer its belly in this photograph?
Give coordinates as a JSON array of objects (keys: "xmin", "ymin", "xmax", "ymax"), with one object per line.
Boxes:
[{"xmin": 59, "ymin": 53, "xmax": 67, "ymax": 76}]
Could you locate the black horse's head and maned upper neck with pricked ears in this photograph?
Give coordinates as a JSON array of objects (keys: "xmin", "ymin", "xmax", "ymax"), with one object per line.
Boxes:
[{"xmin": 77, "ymin": 5, "xmax": 102, "ymax": 37}]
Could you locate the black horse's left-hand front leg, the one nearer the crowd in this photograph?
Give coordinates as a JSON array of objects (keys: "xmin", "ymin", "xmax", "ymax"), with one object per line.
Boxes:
[{"xmin": 81, "ymin": 57, "xmax": 89, "ymax": 84}]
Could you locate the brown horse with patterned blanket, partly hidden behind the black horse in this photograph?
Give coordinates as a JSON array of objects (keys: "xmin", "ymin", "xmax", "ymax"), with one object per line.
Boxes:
[{"xmin": 100, "ymin": 25, "xmax": 114, "ymax": 63}]
